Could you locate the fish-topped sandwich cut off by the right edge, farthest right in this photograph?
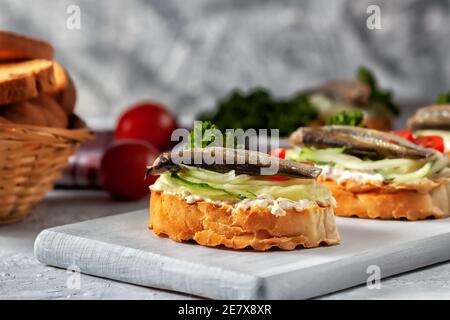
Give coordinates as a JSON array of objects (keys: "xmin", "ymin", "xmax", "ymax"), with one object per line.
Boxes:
[{"xmin": 408, "ymin": 92, "xmax": 450, "ymax": 154}]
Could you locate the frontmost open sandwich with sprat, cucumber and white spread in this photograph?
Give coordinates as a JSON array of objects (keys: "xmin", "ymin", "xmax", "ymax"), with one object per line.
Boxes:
[{"xmin": 148, "ymin": 147, "xmax": 340, "ymax": 250}]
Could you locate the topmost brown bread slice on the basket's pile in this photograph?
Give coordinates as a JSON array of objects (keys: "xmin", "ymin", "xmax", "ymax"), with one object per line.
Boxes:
[{"xmin": 0, "ymin": 31, "xmax": 53, "ymax": 61}]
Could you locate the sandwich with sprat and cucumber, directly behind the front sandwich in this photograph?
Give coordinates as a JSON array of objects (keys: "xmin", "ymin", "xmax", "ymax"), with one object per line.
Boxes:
[{"xmin": 286, "ymin": 126, "xmax": 450, "ymax": 220}]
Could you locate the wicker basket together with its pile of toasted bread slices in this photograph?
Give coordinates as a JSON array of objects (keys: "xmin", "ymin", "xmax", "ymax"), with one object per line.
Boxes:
[{"xmin": 0, "ymin": 31, "xmax": 93, "ymax": 225}]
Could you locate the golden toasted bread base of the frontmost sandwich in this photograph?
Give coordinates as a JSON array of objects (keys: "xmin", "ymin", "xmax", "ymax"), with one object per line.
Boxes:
[{"xmin": 149, "ymin": 191, "xmax": 340, "ymax": 251}]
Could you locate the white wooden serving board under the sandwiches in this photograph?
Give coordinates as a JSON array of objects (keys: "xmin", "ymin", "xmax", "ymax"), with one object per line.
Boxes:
[{"xmin": 35, "ymin": 210, "xmax": 450, "ymax": 299}]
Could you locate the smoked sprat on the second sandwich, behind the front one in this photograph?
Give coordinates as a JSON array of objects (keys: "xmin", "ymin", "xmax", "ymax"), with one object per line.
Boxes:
[{"xmin": 290, "ymin": 126, "xmax": 435, "ymax": 159}]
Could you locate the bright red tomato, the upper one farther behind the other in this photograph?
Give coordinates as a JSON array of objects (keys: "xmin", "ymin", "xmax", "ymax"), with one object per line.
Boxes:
[{"xmin": 115, "ymin": 102, "xmax": 177, "ymax": 150}]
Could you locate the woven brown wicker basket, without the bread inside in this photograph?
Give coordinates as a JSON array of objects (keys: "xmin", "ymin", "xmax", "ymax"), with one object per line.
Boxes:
[{"xmin": 0, "ymin": 116, "xmax": 93, "ymax": 225}]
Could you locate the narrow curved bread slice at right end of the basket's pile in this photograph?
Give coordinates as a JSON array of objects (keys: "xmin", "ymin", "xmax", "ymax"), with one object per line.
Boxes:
[{"xmin": 48, "ymin": 62, "xmax": 77, "ymax": 115}]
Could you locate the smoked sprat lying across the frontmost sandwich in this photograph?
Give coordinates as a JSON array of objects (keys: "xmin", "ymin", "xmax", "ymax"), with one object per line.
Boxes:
[{"xmin": 147, "ymin": 147, "xmax": 321, "ymax": 179}]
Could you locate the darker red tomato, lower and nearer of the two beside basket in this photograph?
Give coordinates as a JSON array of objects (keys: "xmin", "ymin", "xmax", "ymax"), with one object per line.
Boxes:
[{"xmin": 100, "ymin": 140, "xmax": 159, "ymax": 201}]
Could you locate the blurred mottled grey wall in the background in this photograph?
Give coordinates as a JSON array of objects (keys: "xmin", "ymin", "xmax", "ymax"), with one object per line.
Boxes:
[{"xmin": 0, "ymin": 0, "xmax": 450, "ymax": 128}]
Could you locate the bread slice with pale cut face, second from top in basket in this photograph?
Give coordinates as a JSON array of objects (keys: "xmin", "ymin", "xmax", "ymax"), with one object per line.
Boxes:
[{"xmin": 0, "ymin": 60, "xmax": 55, "ymax": 105}]
